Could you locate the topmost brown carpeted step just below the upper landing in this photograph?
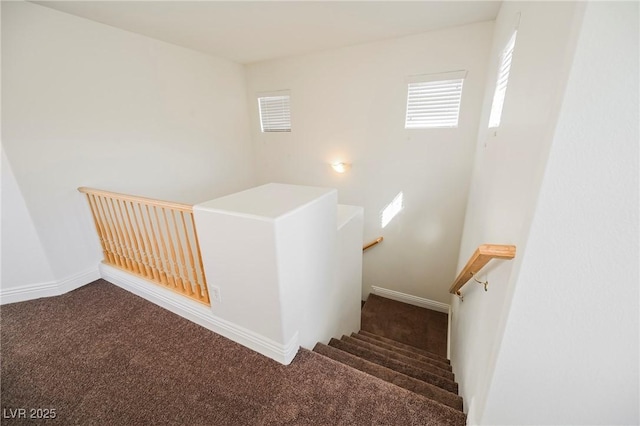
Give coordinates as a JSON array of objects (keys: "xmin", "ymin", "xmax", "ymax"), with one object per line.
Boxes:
[{"xmin": 313, "ymin": 343, "xmax": 462, "ymax": 411}]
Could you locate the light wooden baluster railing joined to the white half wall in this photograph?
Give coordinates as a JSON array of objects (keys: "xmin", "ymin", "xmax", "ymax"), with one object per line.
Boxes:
[{"xmin": 78, "ymin": 187, "xmax": 210, "ymax": 305}]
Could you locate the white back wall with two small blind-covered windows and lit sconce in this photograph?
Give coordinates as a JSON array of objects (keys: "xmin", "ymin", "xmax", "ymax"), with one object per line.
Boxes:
[{"xmin": 247, "ymin": 22, "xmax": 493, "ymax": 302}]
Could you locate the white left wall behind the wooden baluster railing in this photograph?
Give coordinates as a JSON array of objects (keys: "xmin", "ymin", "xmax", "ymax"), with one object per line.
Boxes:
[{"xmin": 2, "ymin": 2, "xmax": 253, "ymax": 287}]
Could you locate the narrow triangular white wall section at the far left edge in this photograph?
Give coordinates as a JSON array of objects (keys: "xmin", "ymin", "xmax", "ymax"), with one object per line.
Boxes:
[{"xmin": 0, "ymin": 150, "xmax": 55, "ymax": 290}]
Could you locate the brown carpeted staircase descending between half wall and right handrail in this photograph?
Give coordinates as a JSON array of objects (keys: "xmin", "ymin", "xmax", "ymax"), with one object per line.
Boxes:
[{"xmin": 313, "ymin": 295, "xmax": 466, "ymax": 425}]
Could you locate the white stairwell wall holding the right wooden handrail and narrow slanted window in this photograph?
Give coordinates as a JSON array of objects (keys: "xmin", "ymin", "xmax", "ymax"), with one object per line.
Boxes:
[{"xmin": 451, "ymin": 2, "xmax": 582, "ymax": 424}]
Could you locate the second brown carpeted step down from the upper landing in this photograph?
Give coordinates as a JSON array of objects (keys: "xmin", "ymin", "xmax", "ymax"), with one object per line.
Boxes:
[{"xmin": 329, "ymin": 339, "xmax": 458, "ymax": 394}]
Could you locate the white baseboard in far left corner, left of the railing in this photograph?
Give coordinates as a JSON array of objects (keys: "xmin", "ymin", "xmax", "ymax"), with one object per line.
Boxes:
[{"xmin": 0, "ymin": 268, "xmax": 100, "ymax": 305}]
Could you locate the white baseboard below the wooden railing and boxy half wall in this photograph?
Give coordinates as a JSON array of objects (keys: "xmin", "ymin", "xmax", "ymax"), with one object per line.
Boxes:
[{"xmin": 100, "ymin": 263, "xmax": 300, "ymax": 365}]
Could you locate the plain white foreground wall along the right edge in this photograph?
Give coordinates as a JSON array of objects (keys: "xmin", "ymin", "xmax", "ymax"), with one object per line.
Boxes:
[{"xmin": 482, "ymin": 2, "xmax": 640, "ymax": 425}]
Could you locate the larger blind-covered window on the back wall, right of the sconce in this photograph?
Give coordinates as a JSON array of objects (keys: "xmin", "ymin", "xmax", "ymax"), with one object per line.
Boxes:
[{"xmin": 404, "ymin": 71, "xmax": 466, "ymax": 129}]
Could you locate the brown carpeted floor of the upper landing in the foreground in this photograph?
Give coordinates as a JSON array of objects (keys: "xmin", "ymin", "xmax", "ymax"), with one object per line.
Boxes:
[{"xmin": 0, "ymin": 280, "xmax": 453, "ymax": 425}]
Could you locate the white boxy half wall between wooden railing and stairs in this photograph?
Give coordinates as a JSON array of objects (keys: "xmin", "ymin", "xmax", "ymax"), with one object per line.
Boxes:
[{"xmin": 194, "ymin": 183, "xmax": 362, "ymax": 361}]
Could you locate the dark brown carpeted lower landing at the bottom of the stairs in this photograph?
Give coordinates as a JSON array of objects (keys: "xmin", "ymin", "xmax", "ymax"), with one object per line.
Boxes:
[{"xmin": 361, "ymin": 294, "xmax": 448, "ymax": 357}]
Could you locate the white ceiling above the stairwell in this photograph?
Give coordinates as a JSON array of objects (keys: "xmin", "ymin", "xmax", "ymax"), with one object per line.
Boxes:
[{"xmin": 34, "ymin": 0, "xmax": 500, "ymax": 64}]
